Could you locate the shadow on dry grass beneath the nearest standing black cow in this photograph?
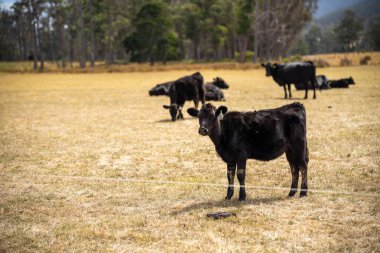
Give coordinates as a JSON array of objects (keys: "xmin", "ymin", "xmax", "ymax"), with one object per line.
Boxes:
[{"xmin": 172, "ymin": 196, "xmax": 288, "ymax": 215}]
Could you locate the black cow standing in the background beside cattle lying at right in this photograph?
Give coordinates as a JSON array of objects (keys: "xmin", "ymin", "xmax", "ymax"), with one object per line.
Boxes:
[{"xmin": 261, "ymin": 61, "xmax": 317, "ymax": 99}]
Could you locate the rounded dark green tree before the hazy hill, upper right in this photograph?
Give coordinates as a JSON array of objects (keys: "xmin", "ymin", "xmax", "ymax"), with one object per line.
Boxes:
[{"xmin": 334, "ymin": 10, "xmax": 363, "ymax": 52}]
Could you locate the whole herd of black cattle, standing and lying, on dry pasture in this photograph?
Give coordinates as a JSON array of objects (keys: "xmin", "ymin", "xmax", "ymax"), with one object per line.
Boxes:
[{"xmin": 149, "ymin": 61, "xmax": 355, "ymax": 200}]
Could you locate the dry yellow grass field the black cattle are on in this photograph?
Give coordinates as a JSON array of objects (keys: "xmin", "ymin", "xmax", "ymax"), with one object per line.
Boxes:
[{"xmin": 0, "ymin": 66, "xmax": 380, "ymax": 252}]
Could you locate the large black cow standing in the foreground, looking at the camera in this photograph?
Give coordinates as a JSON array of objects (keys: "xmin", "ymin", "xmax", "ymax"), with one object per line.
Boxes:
[{"xmin": 187, "ymin": 103, "xmax": 309, "ymax": 200}]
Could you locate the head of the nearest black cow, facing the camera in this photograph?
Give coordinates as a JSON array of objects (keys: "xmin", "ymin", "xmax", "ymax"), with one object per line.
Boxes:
[{"xmin": 187, "ymin": 103, "xmax": 228, "ymax": 136}]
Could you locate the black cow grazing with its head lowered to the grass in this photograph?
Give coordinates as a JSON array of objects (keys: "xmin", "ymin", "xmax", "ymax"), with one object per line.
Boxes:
[{"xmin": 163, "ymin": 72, "xmax": 205, "ymax": 121}]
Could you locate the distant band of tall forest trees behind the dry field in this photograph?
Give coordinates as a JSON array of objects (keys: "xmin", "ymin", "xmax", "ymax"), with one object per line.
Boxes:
[{"xmin": 0, "ymin": 0, "xmax": 380, "ymax": 70}]
